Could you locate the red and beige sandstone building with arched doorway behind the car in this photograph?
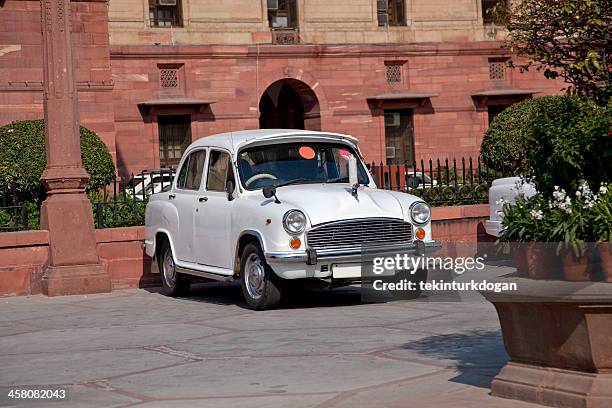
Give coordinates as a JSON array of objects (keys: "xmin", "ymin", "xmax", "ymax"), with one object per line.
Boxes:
[{"xmin": 0, "ymin": 0, "xmax": 562, "ymax": 174}]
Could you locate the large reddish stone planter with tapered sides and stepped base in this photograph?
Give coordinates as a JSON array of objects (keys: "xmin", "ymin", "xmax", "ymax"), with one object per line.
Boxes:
[{"xmin": 482, "ymin": 277, "xmax": 612, "ymax": 408}]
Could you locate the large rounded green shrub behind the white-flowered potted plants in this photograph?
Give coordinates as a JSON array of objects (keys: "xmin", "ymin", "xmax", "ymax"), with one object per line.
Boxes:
[{"xmin": 481, "ymin": 96, "xmax": 612, "ymax": 195}]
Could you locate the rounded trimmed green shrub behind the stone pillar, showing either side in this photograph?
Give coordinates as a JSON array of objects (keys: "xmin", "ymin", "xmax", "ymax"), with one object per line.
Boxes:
[{"xmin": 0, "ymin": 120, "xmax": 115, "ymax": 202}]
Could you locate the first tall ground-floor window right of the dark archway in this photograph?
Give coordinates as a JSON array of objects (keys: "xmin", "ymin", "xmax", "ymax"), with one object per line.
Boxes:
[{"xmin": 385, "ymin": 109, "xmax": 414, "ymax": 166}]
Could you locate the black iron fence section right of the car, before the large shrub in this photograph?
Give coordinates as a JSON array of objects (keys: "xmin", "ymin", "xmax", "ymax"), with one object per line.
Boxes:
[{"xmin": 368, "ymin": 157, "xmax": 514, "ymax": 206}]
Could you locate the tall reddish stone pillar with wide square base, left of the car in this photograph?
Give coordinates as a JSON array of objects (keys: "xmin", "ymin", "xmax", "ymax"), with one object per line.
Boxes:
[{"xmin": 40, "ymin": 0, "xmax": 111, "ymax": 296}]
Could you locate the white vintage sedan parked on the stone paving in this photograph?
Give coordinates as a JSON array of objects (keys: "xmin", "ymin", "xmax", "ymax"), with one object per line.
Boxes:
[{"xmin": 145, "ymin": 130, "xmax": 439, "ymax": 309}]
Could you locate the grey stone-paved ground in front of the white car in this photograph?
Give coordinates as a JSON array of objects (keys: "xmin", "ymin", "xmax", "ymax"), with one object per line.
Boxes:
[{"xmin": 0, "ymin": 264, "xmax": 534, "ymax": 408}]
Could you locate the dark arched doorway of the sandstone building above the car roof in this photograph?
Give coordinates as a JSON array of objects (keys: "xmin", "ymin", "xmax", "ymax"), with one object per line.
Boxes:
[{"xmin": 259, "ymin": 79, "xmax": 321, "ymax": 130}]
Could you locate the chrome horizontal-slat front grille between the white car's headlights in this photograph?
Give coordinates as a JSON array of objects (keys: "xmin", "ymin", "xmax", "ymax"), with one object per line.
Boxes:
[{"xmin": 306, "ymin": 218, "xmax": 412, "ymax": 251}]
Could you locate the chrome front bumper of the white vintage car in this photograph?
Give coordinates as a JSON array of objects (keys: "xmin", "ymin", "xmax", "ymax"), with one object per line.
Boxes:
[{"xmin": 265, "ymin": 241, "xmax": 442, "ymax": 265}]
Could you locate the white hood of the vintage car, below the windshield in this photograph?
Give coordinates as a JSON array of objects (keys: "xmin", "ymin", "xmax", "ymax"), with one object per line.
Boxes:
[{"xmin": 276, "ymin": 184, "xmax": 416, "ymax": 225}]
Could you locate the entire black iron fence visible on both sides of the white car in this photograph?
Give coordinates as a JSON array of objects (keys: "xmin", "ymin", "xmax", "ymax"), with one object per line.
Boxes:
[{"xmin": 0, "ymin": 157, "xmax": 514, "ymax": 232}]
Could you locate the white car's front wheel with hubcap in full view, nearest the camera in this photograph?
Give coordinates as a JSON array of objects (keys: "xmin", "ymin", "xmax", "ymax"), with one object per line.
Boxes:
[{"xmin": 240, "ymin": 244, "xmax": 281, "ymax": 310}]
